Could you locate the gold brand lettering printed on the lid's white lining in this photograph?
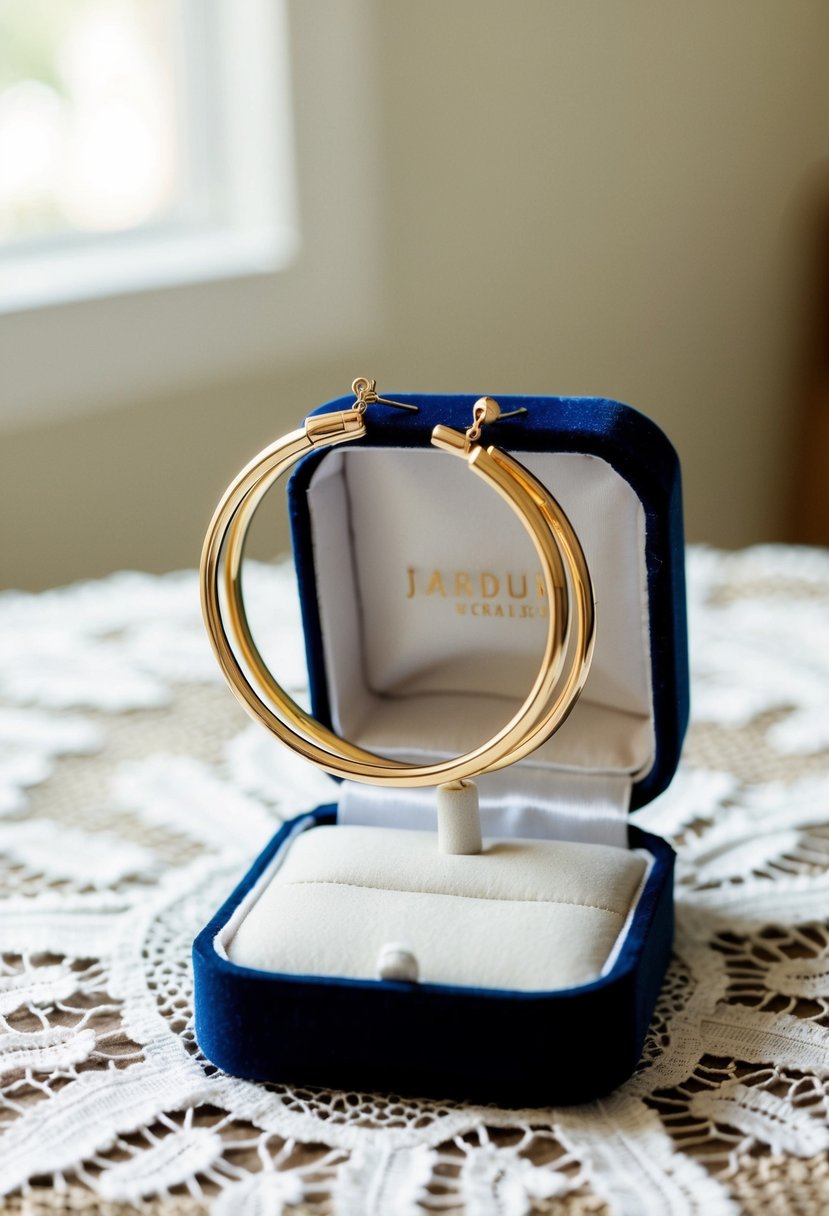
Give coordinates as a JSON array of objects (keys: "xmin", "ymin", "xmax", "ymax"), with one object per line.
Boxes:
[{"xmin": 406, "ymin": 565, "xmax": 547, "ymax": 620}]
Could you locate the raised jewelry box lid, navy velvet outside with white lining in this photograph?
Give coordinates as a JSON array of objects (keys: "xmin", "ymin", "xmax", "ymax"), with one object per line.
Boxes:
[{"xmin": 288, "ymin": 392, "xmax": 688, "ymax": 809}]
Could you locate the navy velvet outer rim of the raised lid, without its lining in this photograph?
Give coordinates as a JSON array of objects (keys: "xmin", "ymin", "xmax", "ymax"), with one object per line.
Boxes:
[{"xmin": 288, "ymin": 393, "xmax": 689, "ymax": 810}]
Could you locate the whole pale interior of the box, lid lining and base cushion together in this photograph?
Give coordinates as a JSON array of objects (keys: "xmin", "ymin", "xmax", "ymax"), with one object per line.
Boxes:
[{"xmin": 218, "ymin": 449, "xmax": 654, "ymax": 991}]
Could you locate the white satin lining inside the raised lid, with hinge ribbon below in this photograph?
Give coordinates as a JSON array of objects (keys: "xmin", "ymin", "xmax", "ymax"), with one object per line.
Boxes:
[{"xmin": 309, "ymin": 449, "xmax": 655, "ymax": 846}]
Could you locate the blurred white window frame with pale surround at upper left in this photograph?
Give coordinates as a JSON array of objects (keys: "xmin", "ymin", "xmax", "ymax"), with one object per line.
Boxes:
[{"xmin": 0, "ymin": 0, "xmax": 380, "ymax": 430}]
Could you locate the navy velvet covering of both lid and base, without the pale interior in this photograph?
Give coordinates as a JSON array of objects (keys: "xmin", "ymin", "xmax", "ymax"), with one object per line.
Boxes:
[{"xmin": 193, "ymin": 393, "xmax": 688, "ymax": 1107}]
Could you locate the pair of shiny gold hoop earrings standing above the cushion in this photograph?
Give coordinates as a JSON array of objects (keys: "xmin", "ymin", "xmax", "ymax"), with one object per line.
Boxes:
[{"xmin": 201, "ymin": 377, "xmax": 596, "ymax": 786}]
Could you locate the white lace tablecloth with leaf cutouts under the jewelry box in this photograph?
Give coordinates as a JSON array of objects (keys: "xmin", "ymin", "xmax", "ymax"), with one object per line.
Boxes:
[{"xmin": 0, "ymin": 547, "xmax": 829, "ymax": 1216}]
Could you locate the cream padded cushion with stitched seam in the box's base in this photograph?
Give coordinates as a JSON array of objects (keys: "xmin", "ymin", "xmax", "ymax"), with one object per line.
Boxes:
[{"xmin": 219, "ymin": 826, "xmax": 647, "ymax": 991}]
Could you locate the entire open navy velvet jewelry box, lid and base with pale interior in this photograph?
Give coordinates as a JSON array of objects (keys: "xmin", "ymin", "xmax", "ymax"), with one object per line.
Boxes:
[{"xmin": 193, "ymin": 394, "xmax": 688, "ymax": 1105}]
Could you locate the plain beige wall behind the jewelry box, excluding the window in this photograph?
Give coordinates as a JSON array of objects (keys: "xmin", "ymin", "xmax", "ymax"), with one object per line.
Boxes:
[{"xmin": 0, "ymin": 0, "xmax": 829, "ymax": 587}]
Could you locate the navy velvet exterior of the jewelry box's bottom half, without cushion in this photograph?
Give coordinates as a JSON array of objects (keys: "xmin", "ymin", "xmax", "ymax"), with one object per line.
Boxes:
[{"xmin": 193, "ymin": 806, "xmax": 673, "ymax": 1107}]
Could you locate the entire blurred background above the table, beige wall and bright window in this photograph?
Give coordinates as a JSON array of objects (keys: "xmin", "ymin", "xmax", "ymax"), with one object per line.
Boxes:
[{"xmin": 0, "ymin": 0, "xmax": 829, "ymax": 589}]
